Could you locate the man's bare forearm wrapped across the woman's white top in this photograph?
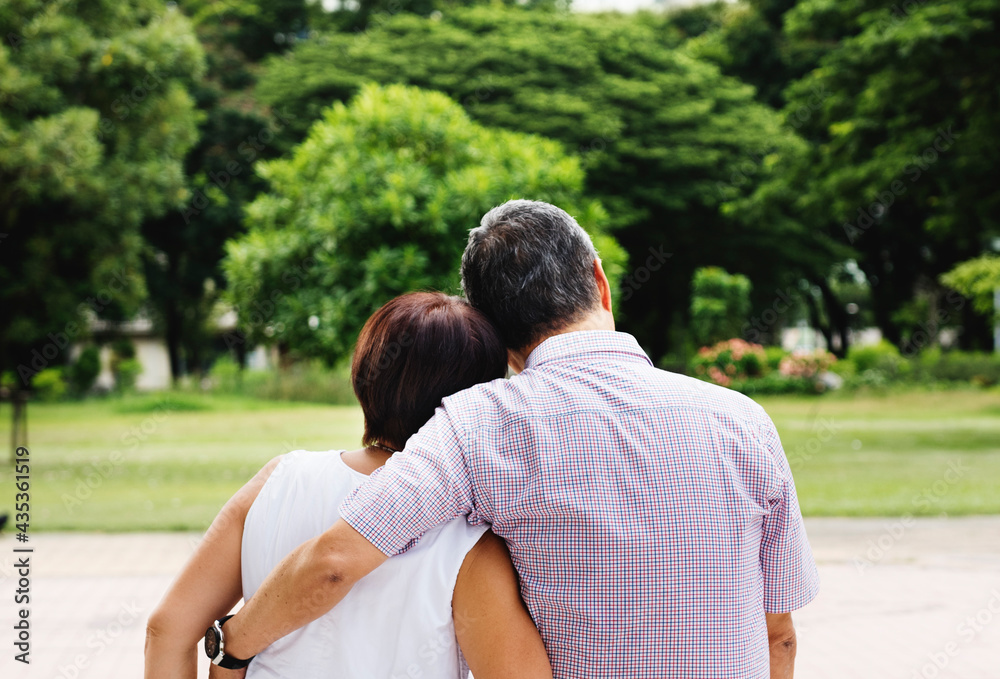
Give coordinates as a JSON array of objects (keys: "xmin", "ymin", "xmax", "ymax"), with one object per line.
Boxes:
[{"xmin": 224, "ymin": 520, "xmax": 386, "ymax": 658}]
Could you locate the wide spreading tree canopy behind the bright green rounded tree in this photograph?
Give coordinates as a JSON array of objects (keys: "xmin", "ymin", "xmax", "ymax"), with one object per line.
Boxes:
[{"xmin": 257, "ymin": 8, "xmax": 829, "ymax": 356}]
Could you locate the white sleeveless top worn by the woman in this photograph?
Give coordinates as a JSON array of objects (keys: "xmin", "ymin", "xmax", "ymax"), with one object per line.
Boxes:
[{"xmin": 242, "ymin": 450, "xmax": 487, "ymax": 679}]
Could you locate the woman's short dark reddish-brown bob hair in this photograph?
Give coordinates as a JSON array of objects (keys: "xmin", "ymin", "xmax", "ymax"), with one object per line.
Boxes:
[{"xmin": 351, "ymin": 292, "xmax": 507, "ymax": 450}]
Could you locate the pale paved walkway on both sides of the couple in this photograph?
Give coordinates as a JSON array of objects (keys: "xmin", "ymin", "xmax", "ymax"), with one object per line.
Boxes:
[{"xmin": 0, "ymin": 517, "xmax": 1000, "ymax": 679}]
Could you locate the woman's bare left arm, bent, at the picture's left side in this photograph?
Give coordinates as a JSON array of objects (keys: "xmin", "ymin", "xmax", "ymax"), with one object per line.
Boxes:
[{"xmin": 145, "ymin": 457, "xmax": 281, "ymax": 679}]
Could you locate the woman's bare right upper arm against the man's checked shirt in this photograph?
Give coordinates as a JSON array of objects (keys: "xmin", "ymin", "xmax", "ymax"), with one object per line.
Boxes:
[{"xmin": 452, "ymin": 531, "xmax": 552, "ymax": 679}]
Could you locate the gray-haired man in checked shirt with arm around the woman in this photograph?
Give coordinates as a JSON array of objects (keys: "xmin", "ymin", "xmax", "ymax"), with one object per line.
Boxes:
[{"xmin": 215, "ymin": 200, "xmax": 818, "ymax": 679}]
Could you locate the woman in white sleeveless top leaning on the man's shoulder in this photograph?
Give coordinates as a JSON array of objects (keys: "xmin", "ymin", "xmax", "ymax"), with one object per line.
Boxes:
[{"xmin": 146, "ymin": 292, "xmax": 552, "ymax": 679}]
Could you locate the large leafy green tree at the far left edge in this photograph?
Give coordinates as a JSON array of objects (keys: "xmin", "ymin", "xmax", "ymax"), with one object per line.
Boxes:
[{"xmin": 0, "ymin": 0, "xmax": 203, "ymax": 387}]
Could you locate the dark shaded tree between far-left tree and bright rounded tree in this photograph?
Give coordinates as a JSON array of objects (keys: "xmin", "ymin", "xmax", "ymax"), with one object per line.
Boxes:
[{"xmin": 142, "ymin": 0, "xmax": 309, "ymax": 380}]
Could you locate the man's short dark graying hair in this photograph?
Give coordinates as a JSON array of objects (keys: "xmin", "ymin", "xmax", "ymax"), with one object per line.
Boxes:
[{"xmin": 462, "ymin": 200, "xmax": 600, "ymax": 349}]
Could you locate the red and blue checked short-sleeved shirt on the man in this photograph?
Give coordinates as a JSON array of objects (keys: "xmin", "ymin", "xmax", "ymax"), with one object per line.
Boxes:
[{"xmin": 341, "ymin": 332, "xmax": 819, "ymax": 679}]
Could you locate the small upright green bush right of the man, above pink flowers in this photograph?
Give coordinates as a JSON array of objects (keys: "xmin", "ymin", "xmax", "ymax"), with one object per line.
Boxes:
[{"xmin": 691, "ymin": 266, "xmax": 752, "ymax": 346}]
